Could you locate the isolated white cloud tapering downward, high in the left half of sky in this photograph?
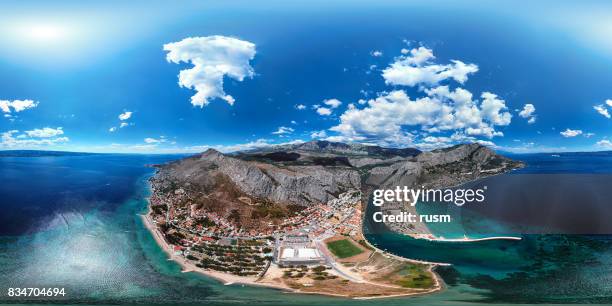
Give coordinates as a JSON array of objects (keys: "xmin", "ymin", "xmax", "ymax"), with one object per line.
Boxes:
[{"xmin": 164, "ymin": 35, "xmax": 255, "ymax": 107}]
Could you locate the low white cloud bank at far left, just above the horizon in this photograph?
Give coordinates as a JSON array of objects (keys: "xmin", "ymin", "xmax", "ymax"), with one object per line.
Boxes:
[{"xmin": 0, "ymin": 128, "xmax": 69, "ymax": 149}]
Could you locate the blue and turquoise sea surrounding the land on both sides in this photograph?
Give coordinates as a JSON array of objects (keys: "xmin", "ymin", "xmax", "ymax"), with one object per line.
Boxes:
[{"xmin": 0, "ymin": 153, "xmax": 612, "ymax": 306}]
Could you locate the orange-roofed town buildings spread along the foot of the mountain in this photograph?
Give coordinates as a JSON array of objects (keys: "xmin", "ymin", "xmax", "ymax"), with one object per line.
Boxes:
[{"xmin": 150, "ymin": 172, "xmax": 361, "ymax": 276}]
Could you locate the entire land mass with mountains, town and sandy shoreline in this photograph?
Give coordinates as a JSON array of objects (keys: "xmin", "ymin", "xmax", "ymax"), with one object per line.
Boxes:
[{"xmin": 143, "ymin": 141, "xmax": 522, "ymax": 298}]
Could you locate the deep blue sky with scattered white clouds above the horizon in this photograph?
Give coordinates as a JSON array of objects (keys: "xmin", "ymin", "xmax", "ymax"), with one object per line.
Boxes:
[{"xmin": 0, "ymin": 0, "xmax": 612, "ymax": 153}]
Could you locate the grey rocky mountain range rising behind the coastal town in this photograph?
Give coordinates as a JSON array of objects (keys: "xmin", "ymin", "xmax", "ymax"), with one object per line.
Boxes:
[{"xmin": 153, "ymin": 141, "xmax": 522, "ymax": 228}]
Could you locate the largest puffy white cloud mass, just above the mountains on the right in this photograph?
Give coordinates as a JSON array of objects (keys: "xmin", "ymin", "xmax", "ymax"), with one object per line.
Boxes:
[{"xmin": 330, "ymin": 86, "xmax": 512, "ymax": 145}]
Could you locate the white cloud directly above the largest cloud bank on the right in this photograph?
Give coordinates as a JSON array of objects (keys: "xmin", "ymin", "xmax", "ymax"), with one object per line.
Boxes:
[{"xmin": 383, "ymin": 47, "xmax": 478, "ymax": 86}]
